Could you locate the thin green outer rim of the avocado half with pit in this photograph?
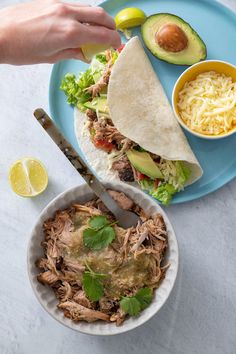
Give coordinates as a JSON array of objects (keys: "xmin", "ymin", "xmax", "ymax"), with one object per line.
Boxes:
[{"xmin": 141, "ymin": 13, "xmax": 207, "ymax": 66}]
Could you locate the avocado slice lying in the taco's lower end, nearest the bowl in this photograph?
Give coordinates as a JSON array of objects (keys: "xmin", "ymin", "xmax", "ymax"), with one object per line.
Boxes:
[{"xmin": 126, "ymin": 149, "xmax": 163, "ymax": 179}]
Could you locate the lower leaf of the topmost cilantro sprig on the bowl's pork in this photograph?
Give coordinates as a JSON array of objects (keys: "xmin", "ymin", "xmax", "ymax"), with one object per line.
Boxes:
[{"xmin": 83, "ymin": 226, "xmax": 115, "ymax": 250}]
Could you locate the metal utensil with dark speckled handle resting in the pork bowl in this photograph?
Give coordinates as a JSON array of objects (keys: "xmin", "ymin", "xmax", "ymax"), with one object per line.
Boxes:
[{"xmin": 34, "ymin": 108, "xmax": 140, "ymax": 229}]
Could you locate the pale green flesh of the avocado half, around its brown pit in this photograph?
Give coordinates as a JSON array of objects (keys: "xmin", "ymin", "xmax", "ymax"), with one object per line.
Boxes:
[{"xmin": 141, "ymin": 13, "xmax": 207, "ymax": 65}]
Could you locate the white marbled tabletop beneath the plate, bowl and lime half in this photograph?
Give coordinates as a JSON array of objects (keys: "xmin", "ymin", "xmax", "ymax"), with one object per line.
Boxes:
[{"xmin": 0, "ymin": 0, "xmax": 236, "ymax": 354}]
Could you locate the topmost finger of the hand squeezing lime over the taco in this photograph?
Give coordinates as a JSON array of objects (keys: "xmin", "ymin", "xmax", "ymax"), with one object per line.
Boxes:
[{"xmin": 74, "ymin": 7, "xmax": 116, "ymax": 30}]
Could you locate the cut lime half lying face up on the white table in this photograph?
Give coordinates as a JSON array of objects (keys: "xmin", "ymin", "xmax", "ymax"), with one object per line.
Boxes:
[{"xmin": 9, "ymin": 157, "xmax": 48, "ymax": 197}]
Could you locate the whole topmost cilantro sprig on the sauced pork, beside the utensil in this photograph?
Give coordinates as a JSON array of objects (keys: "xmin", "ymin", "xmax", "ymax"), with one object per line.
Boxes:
[{"xmin": 83, "ymin": 215, "xmax": 116, "ymax": 250}]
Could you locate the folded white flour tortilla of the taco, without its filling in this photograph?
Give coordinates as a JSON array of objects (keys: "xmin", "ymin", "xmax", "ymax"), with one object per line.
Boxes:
[{"xmin": 75, "ymin": 37, "xmax": 203, "ymax": 185}]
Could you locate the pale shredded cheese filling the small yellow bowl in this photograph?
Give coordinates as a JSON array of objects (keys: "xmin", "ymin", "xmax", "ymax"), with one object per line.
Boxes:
[{"xmin": 178, "ymin": 71, "xmax": 236, "ymax": 135}]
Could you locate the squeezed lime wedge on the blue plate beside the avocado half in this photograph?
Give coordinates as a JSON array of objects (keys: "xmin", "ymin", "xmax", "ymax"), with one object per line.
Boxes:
[{"xmin": 114, "ymin": 7, "xmax": 147, "ymax": 30}]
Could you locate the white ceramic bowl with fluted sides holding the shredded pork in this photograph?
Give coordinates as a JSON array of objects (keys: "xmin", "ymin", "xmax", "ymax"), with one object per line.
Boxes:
[{"xmin": 28, "ymin": 182, "xmax": 178, "ymax": 335}]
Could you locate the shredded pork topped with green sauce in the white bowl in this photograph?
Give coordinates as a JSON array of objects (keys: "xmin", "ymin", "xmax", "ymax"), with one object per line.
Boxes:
[{"xmin": 36, "ymin": 191, "xmax": 168, "ymax": 325}]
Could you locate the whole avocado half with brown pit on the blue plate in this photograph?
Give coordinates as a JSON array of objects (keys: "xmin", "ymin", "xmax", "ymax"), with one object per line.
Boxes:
[{"xmin": 141, "ymin": 13, "xmax": 207, "ymax": 65}]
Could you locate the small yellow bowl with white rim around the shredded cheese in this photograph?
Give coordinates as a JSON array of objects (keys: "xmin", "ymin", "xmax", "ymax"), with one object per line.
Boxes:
[{"xmin": 172, "ymin": 60, "xmax": 236, "ymax": 140}]
